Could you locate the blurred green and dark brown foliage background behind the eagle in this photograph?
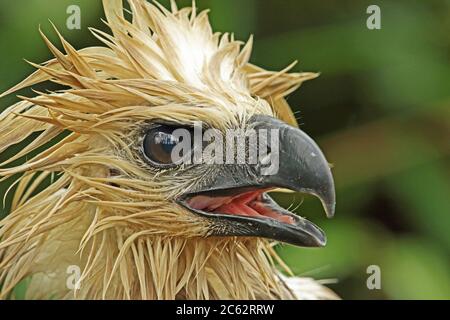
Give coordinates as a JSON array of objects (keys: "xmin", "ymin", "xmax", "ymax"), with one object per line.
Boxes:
[{"xmin": 0, "ymin": 0, "xmax": 450, "ymax": 299}]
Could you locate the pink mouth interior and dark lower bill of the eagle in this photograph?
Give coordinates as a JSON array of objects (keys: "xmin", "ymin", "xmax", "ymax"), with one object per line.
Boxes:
[{"xmin": 179, "ymin": 188, "xmax": 327, "ymax": 247}]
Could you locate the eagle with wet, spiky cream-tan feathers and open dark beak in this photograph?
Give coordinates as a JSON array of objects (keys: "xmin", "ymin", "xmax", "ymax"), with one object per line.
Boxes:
[{"xmin": 0, "ymin": 0, "xmax": 336, "ymax": 299}]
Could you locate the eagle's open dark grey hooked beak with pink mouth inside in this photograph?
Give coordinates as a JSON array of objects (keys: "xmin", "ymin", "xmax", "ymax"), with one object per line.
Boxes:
[{"xmin": 179, "ymin": 116, "xmax": 336, "ymax": 247}]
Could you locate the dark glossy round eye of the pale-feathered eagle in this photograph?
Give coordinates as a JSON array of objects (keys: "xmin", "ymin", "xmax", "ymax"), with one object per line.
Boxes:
[{"xmin": 143, "ymin": 125, "xmax": 183, "ymax": 167}]
